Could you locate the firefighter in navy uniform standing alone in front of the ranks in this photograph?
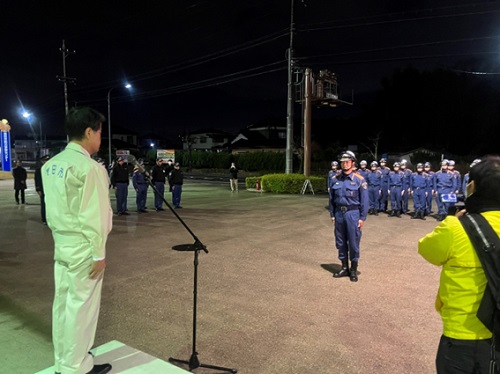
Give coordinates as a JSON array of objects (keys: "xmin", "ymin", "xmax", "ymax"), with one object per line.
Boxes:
[{"xmin": 329, "ymin": 151, "xmax": 368, "ymax": 282}]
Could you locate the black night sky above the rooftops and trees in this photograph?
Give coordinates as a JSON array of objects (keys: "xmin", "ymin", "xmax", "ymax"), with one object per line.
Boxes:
[{"xmin": 0, "ymin": 0, "xmax": 500, "ymax": 141}]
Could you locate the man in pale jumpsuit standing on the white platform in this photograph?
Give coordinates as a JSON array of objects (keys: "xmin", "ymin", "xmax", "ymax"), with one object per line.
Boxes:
[{"xmin": 42, "ymin": 107, "xmax": 113, "ymax": 374}]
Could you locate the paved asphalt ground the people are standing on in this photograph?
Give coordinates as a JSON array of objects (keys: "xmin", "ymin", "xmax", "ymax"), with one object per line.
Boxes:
[{"xmin": 0, "ymin": 175, "xmax": 441, "ymax": 374}]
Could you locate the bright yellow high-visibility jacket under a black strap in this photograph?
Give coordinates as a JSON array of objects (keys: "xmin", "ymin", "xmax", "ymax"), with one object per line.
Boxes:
[{"xmin": 418, "ymin": 211, "xmax": 500, "ymax": 340}]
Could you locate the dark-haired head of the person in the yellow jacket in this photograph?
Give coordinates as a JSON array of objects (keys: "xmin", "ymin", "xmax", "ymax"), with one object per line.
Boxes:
[{"xmin": 469, "ymin": 155, "xmax": 500, "ymax": 203}]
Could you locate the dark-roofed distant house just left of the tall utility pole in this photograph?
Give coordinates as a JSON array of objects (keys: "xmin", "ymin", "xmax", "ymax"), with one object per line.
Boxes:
[{"xmin": 226, "ymin": 121, "xmax": 286, "ymax": 153}]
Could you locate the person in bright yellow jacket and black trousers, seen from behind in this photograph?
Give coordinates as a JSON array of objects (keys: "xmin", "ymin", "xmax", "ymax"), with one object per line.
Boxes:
[{"xmin": 418, "ymin": 156, "xmax": 500, "ymax": 374}]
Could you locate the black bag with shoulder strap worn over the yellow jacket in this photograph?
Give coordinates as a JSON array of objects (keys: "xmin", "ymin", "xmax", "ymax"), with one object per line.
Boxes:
[{"xmin": 460, "ymin": 214, "xmax": 500, "ymax": 334}]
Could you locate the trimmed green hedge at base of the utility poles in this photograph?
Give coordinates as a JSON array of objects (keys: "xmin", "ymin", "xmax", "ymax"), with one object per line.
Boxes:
[{"xmin": 245, "ymin": 174, "xmax": 326, "ymax": 194}]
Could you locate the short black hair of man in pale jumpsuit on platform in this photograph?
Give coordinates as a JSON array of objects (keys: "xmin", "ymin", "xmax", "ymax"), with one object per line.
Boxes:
[{"xmin": 64, "ymin": 107, "xmax": 106, "ymax": 140}]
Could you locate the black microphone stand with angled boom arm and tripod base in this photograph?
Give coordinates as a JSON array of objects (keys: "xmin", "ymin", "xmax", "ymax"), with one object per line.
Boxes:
[{"xmin": 128, "ymin": 155, "xmax": 238, "ymax": 373}]
